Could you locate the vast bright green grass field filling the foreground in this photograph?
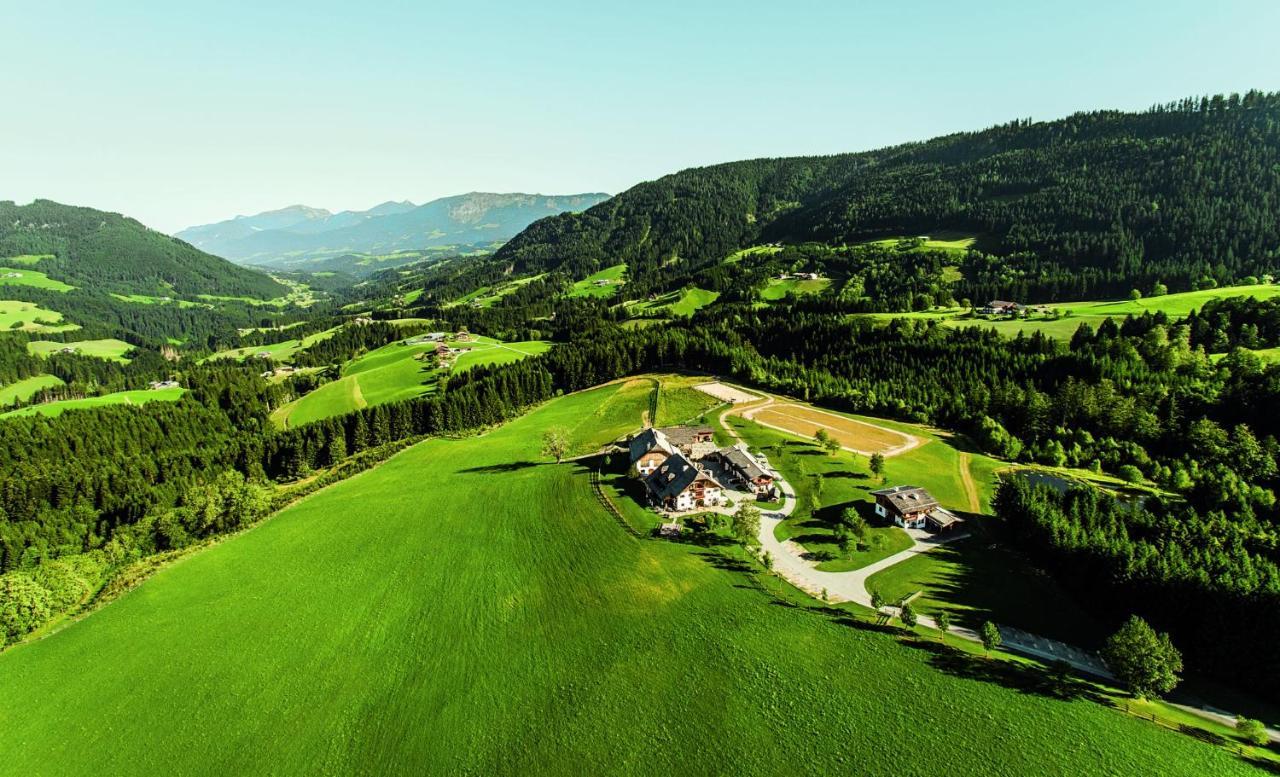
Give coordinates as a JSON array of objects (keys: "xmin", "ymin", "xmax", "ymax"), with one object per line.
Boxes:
[{"xmin": 0, "ymin": 381, "xmax": 1253, "ymax": 777}]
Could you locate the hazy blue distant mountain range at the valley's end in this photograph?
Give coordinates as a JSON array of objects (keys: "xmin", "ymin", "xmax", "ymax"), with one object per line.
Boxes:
[{"xmin": 174, "ymin": 192, "xmax": 609, "ymax": 270}]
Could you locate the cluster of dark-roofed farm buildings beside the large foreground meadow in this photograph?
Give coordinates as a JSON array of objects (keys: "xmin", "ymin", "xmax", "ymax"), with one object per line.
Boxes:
[{"xmin": 627, "ymin": 426, "xmax": 774, "ymax": 512}]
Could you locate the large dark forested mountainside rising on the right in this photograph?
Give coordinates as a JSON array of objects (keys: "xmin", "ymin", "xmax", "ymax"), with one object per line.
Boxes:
[{"xmin": 498, "ymin": 92, "xmax": 1280, "ymax": 301}]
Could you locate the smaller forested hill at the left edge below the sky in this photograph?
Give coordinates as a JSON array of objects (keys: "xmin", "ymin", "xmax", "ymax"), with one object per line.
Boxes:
[{"xmin": 0, "ymin": 200, "xmax": 288, "ymax": 300}]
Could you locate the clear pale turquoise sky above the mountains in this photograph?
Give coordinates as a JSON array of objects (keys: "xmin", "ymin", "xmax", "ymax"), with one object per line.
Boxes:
[{"xmin": 0, "ymin": 0, "xmax": 1280, "ymax": 232}]
